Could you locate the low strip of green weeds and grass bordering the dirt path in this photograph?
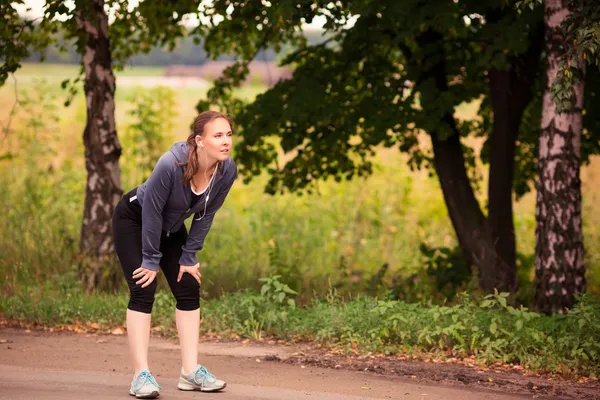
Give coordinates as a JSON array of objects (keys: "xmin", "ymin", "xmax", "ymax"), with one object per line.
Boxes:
[{"xmin": 0, "ymin": 282, "xmax": 600, "ymax": 377}]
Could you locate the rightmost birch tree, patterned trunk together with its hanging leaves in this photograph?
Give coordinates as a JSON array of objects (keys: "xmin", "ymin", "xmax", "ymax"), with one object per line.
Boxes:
[{"xmin": 517, "ymin": 0, "xmax": 600, "ymax": 313}]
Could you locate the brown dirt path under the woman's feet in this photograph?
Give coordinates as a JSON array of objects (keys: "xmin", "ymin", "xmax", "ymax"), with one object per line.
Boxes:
[{"xmin": 0, "ymin": 328, "xmax": 592, "ymax": 400}]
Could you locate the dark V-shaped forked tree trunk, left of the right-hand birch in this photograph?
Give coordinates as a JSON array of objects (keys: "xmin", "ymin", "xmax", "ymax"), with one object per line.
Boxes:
[{"xmin": 431, "ymin": 27, "xmax": 543, "ymax": 293}]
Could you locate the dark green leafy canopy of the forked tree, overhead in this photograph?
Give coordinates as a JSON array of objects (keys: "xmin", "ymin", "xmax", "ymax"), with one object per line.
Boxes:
[{"xmin": 197, "ymin": 0, "xmax": 556, "ymax": 198}]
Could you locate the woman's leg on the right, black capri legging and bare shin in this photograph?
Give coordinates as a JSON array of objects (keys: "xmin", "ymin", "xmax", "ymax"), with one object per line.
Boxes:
[{"xmin": 161, "ymin": 228, "xmax": 200, "ymax": 372}]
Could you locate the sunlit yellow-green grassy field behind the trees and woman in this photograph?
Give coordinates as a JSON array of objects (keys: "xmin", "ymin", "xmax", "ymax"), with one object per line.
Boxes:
[{"xmin": 0, "ymin": 64, "xmax": 600, "ymax": 301}]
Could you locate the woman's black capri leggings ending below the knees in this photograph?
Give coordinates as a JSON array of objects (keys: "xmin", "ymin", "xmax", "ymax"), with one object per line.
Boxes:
[{"xmin": 112, "ymin": 189, "xmax": 200, "ymax": 314}]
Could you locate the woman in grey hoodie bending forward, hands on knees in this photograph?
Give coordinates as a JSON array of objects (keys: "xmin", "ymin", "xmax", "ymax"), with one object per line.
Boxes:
[{"xmin": 113, "ymin": 111, "xmax": 237, "ymax": 399}]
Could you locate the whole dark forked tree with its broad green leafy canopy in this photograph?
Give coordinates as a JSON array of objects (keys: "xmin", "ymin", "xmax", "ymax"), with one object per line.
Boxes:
[{"xmin": 198, "ymin": 0, "xmax": 543, "ymax": 292}]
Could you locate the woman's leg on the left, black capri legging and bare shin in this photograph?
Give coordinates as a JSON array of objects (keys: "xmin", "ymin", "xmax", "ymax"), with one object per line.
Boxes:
[{"xmin": 113, "ymin": 195, "xmax": 156, "ymax": 375}]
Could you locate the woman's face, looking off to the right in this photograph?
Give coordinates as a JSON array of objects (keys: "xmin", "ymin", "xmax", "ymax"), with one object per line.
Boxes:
[{"xmin": 196, "ymin": 118, "xmax": 232, "ymax": 164}]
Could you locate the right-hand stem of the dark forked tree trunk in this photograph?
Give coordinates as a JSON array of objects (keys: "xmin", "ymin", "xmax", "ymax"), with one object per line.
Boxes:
[{"xmin": 486, "ymin": 21, "xmax": 544, "ymax": 292}]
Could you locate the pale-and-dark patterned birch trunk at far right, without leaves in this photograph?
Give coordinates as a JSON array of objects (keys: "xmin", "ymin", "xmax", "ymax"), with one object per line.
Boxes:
[{"xmin": 535, "ymin": 0, "xmax": 585, "ymax": 313}]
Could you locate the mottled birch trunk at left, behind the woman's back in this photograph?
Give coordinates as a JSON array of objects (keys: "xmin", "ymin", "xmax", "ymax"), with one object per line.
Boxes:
[{"xmin": 76, "ymin": 0, "xmax": 123, "ymax": 291}]
